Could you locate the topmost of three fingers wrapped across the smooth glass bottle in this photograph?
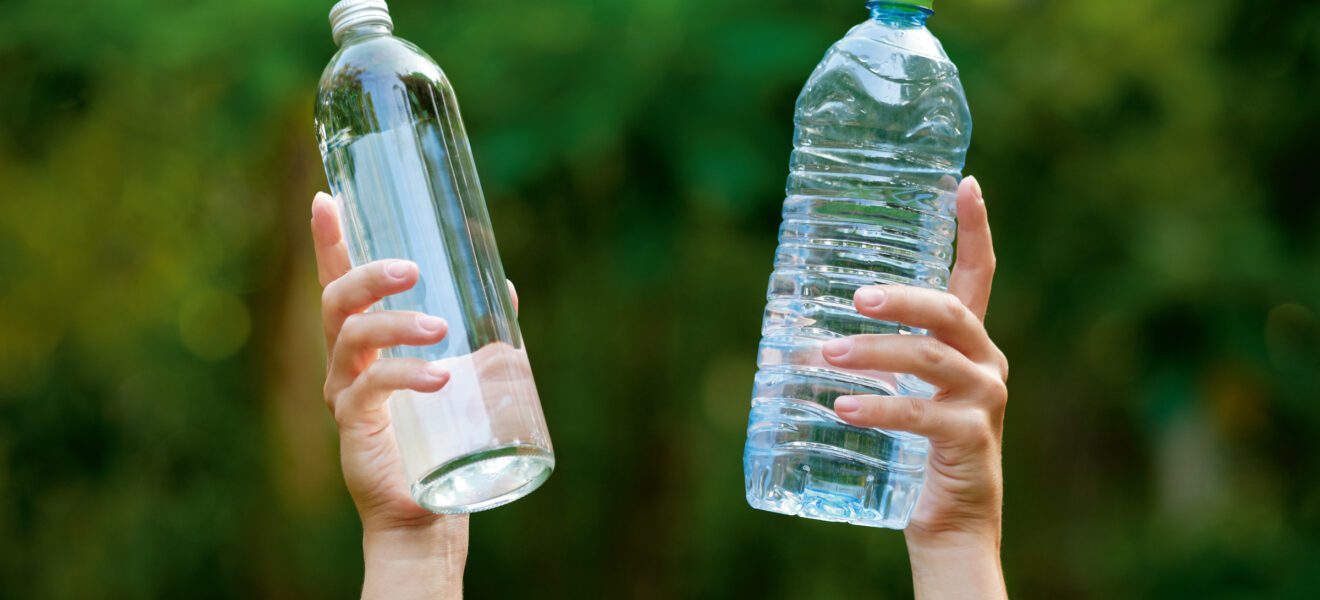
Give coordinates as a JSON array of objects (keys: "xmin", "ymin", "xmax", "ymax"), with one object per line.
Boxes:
[{"xmin": 321, "ymin": 260, "xmax": 417, "ymax": 348}]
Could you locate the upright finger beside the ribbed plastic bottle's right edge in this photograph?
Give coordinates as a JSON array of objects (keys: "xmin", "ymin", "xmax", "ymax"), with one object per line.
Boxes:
[{"xmin": 949, "ymin": 177, "xmax": 995, "ymax": 320}]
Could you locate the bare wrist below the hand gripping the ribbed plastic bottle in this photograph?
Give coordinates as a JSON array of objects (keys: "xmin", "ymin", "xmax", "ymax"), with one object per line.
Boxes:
[{"xmin": 907, "ymin": 534, "xmax": 1008, "ymax": 600}]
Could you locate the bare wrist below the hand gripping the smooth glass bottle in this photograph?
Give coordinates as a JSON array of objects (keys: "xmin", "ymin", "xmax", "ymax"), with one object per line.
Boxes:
[{"xmin": 362, "ymin": 516, "xmax": 467, "ymax": 600}]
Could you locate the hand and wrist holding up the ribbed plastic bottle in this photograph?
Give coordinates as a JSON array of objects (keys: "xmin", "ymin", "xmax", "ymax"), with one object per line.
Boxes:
[{"xmin": 821, "ymin": 177, "xmax": 1008, "ymax": 599}]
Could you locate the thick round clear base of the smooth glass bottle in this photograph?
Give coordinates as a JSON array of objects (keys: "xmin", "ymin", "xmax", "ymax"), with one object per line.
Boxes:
[{"xmin": 412, "ymin": 444, "xmax": 554, "ymax": 514}]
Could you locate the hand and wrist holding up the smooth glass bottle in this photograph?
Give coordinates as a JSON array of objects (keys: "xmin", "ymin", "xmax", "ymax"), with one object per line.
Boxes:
[{"xmin": 312, "ymin": 194, "xmax": 517, "ymax": 597}]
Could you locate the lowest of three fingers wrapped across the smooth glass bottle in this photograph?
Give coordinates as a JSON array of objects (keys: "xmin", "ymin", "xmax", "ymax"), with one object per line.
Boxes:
[{"xmin": 326, "ymin": 359, "xmax": 449, "ymax": 429}]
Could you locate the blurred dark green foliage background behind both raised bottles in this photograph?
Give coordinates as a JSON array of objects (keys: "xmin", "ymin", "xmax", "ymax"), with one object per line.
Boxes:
[{"xmin": 0, "ymin": 0, "xmax": 1320, "ymax": 599}]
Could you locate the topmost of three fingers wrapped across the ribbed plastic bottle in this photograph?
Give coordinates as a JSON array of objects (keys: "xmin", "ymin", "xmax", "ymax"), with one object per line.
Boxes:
[{"xmin": 853, "ymin": 285, "xmax": 1001, "ymax": 364}]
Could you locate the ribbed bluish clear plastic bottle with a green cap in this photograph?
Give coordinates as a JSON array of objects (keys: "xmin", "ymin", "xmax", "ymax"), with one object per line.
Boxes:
[{"xmin": 743, "ymin": 0, "xmax": 972, "ymax": 529}]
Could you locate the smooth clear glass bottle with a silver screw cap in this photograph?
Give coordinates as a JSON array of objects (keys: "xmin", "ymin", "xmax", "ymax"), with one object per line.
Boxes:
[{"xmin": 315, "ymin": 0, "xmax": 554, "ymax": 513}]
